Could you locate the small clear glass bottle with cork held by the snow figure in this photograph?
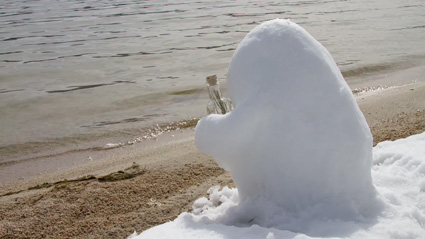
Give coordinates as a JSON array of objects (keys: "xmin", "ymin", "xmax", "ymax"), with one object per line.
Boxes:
[{"xmin": 207, "ymin": 75, "xmax": 233, "ymax": 115}]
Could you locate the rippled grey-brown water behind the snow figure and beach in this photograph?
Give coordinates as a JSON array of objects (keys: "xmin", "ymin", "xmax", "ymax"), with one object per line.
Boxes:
[{"xmin": 0, "ymin": 0, "xmax": 425, "ymax": 148}]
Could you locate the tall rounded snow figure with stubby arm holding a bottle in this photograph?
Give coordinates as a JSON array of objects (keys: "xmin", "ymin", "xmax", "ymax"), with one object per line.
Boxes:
[{"xmin": 195, "ymin": 19, "xmax": 377, "ymax": 222}]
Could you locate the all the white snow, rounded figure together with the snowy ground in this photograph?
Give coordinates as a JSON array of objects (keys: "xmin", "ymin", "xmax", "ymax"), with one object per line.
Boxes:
[{"xmin": 131, "ymin": 19, "xmax": 425, "ymax": 239}]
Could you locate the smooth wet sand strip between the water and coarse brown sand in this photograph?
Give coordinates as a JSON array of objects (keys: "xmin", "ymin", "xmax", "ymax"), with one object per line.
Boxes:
[{"xmin": 0, "ymin": 76, "xmax": 425, "ymax": 192}]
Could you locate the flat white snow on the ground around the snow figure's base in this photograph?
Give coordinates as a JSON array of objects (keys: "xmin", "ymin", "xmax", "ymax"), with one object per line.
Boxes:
[{"xmin": 130, "ymin": 132, "xmax": 425, "ymax": 239}]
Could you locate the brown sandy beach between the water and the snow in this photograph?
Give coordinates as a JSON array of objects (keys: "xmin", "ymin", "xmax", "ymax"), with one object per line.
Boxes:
[{"xmin": 0, "ymin": 64, "xmax": 425, "ymax": 238}]
